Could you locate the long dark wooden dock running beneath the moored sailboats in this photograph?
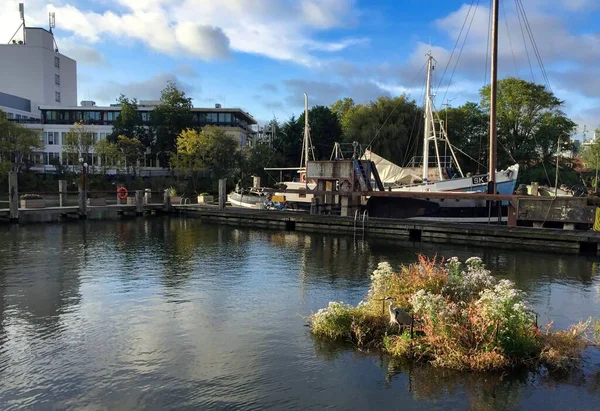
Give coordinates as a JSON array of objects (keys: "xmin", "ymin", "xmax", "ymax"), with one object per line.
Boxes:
[{"xmin": 173, "ymin": 204, "xmax": 600, "ymax": 254}]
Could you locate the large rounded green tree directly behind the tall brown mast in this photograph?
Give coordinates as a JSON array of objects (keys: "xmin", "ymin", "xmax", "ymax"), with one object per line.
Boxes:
[{"xmin": 480, "ymin": 77, "xmax": 576, "ymax": 168}]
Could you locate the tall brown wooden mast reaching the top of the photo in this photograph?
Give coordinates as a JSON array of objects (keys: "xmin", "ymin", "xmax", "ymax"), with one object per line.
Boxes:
[{"xmin": 488, "ymin": 0, "xmax": 499, "ymax": 194}]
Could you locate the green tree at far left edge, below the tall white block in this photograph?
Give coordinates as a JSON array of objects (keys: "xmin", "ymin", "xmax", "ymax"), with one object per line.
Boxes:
[{"xmin": 0, "ymin": 110, "xmax": 43, "ymax": 174}]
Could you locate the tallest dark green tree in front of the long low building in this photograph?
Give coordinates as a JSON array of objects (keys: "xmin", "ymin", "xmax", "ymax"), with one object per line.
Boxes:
[{"xmin": 150, "ymin": 82, "xmax": 193, "ymax": 164}]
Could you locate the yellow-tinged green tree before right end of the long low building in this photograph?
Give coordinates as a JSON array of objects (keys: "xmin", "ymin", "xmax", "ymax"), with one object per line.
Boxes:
[{"xmin": 171, "ymin": 126, "xmax": 240, "ymax": 192}]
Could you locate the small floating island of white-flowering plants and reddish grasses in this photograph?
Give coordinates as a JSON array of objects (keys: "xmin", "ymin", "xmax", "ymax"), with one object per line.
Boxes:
[{"xmin": 310, "ymin": 257, "xmax": 599, "ymax": 371}]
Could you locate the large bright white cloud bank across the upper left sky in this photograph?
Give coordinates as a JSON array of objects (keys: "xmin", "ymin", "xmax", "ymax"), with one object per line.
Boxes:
[{"xmin": 0, "ymin": 0, "xmax": 364, "ymax": 65}]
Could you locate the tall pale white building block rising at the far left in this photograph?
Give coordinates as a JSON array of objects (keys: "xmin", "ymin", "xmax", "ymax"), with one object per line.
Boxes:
[{"xmin": 0, "ymin": 27, "xmax": 77, "ymax": 120}]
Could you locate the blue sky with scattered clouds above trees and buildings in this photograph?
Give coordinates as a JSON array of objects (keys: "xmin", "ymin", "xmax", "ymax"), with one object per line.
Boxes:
[{"xmin": 0, "ymin": 0, "xmax": 600, "ymax": 137}]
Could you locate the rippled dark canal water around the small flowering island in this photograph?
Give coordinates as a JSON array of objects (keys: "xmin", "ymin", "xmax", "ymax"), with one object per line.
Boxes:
[{"xmin": 0, "ymin": 218, "xmax": 600, "ymax": 410}]
